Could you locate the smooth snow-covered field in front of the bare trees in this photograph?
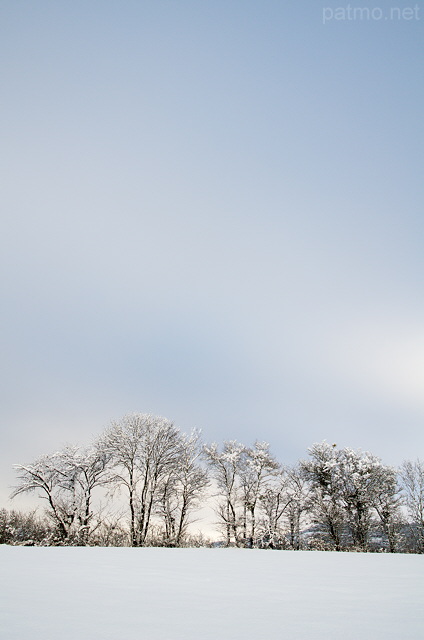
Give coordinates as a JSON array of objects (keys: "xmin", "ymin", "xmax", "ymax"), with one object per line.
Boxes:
[{"xmin": 0, "ymin": 546, "xmax": 424, "ymax": 640}]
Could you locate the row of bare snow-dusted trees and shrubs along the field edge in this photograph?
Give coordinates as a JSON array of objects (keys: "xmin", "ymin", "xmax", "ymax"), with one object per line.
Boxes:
[{"xmin": 5, "ymin": 414, "xmax": 424, "ymax": 553}]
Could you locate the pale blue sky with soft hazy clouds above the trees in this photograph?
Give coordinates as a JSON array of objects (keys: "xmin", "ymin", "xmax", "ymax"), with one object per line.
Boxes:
[{"xmin": 0, "ymin": 0, "xmax": 424, "ymax": 507}]
